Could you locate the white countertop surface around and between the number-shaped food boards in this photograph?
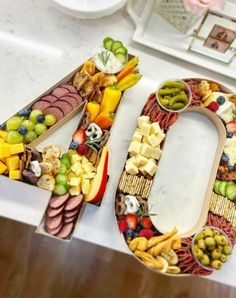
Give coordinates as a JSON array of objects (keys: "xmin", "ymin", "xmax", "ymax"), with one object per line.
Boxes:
[{"xmin": 0, "ymin": 0, "xmax": 236, "ymax": 286}]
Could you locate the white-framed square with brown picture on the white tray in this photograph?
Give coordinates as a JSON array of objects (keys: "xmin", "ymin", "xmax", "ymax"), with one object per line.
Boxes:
[{"xmin": 189, "ymin": 11, "xmax": 236, "ymax": 63}]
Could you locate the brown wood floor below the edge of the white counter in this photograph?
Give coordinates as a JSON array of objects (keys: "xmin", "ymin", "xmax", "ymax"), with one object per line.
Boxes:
[{"xmin": 0, "ymin": 218, "xmax": 236, "ymax": 298}]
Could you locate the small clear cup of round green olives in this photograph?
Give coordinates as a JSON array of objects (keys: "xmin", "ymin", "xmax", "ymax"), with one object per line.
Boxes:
[{"xmin": 192, "ymin": 226, "xmax": 233, "ymax": 270}]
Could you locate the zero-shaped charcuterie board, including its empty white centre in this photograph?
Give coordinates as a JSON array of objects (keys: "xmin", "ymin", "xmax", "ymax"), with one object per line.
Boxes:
[{"xmin": 115, "ymin": 78, "xmax": 236, "ymax": 276}]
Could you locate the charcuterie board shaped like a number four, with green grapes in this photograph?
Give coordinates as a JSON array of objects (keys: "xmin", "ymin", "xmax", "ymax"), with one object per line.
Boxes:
[{"xmin": 0, "ymin": 37, "xmax": 141, "ymax": 241}]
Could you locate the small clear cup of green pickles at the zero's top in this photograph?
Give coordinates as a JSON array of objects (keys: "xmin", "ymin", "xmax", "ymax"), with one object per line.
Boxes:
[{"xmin": 156, "ymin": 80, "xmax": 192, "ymax": 112}]
